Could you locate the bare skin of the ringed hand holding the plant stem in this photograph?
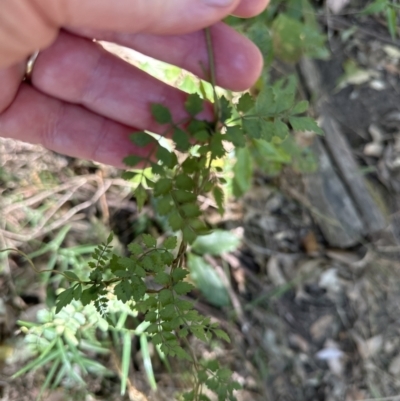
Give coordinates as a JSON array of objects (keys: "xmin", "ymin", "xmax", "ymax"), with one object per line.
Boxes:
[{"xmin": 0, "ymin": 0, "xmax": 268, "ymax": 167}]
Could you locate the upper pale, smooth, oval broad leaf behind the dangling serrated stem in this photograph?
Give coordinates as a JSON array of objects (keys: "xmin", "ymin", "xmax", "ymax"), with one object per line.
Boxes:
[{"xmin": 192, "ymin": 230, "xmax": 240, "ymax": 255}]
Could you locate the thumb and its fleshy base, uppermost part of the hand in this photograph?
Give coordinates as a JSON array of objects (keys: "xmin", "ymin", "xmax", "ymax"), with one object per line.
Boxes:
[{"xmin": 0, "ymin": 0, "xmax": 240, "ymax": 68}]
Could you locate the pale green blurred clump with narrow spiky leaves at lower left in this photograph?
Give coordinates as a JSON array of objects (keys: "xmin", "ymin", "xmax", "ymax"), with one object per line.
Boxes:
[{"xmin": 13, "ymin": 300, "xmax": 112, "ymax": 399}]
